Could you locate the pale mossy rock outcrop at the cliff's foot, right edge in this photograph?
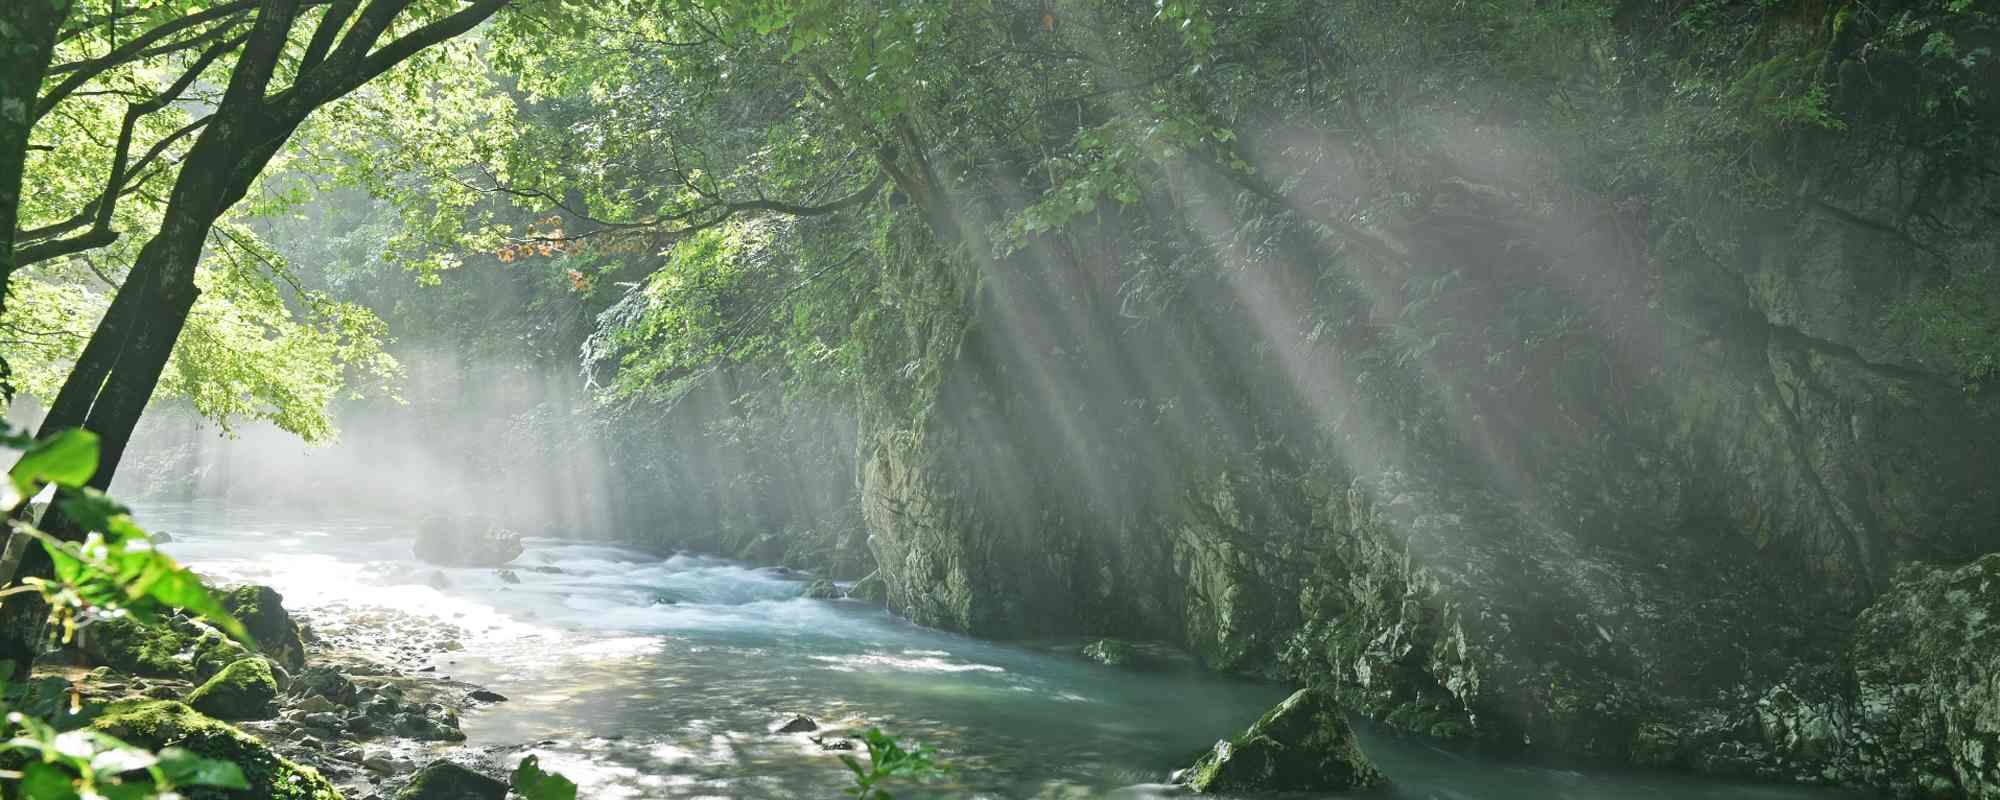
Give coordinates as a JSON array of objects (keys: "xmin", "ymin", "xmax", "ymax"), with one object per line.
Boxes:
[{"xmin": 1852, "ymin": 552, "xmax": 2000, "ymax": 800}]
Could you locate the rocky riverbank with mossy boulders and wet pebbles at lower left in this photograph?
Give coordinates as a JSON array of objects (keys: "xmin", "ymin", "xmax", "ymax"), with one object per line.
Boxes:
[{"xmin": 38, "ymin": 586, "xmax": 512, "ymax": 800}]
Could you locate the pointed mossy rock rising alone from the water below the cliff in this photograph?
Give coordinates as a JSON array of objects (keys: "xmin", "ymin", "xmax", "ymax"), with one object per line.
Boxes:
[{"xmin": 1178, "ymin": 688, "xmax": 1386, "ymax": 792}]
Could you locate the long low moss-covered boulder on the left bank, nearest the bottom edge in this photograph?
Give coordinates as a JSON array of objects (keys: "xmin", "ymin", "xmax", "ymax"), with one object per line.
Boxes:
[{"xmin": 90, "ymin": 700, "xmax": 340, "ymax": 800}]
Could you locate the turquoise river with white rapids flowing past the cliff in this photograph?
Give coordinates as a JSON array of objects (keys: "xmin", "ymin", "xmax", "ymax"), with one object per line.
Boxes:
[{"xmin": 138, "ymin": 504, "xmax": 1872, "ymax": 800}]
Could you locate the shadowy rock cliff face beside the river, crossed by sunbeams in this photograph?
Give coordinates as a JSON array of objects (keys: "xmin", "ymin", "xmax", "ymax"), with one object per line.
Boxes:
[{"xmin": 862, "ymin": 0, "xmax": 2000, "ymax": 796}]
